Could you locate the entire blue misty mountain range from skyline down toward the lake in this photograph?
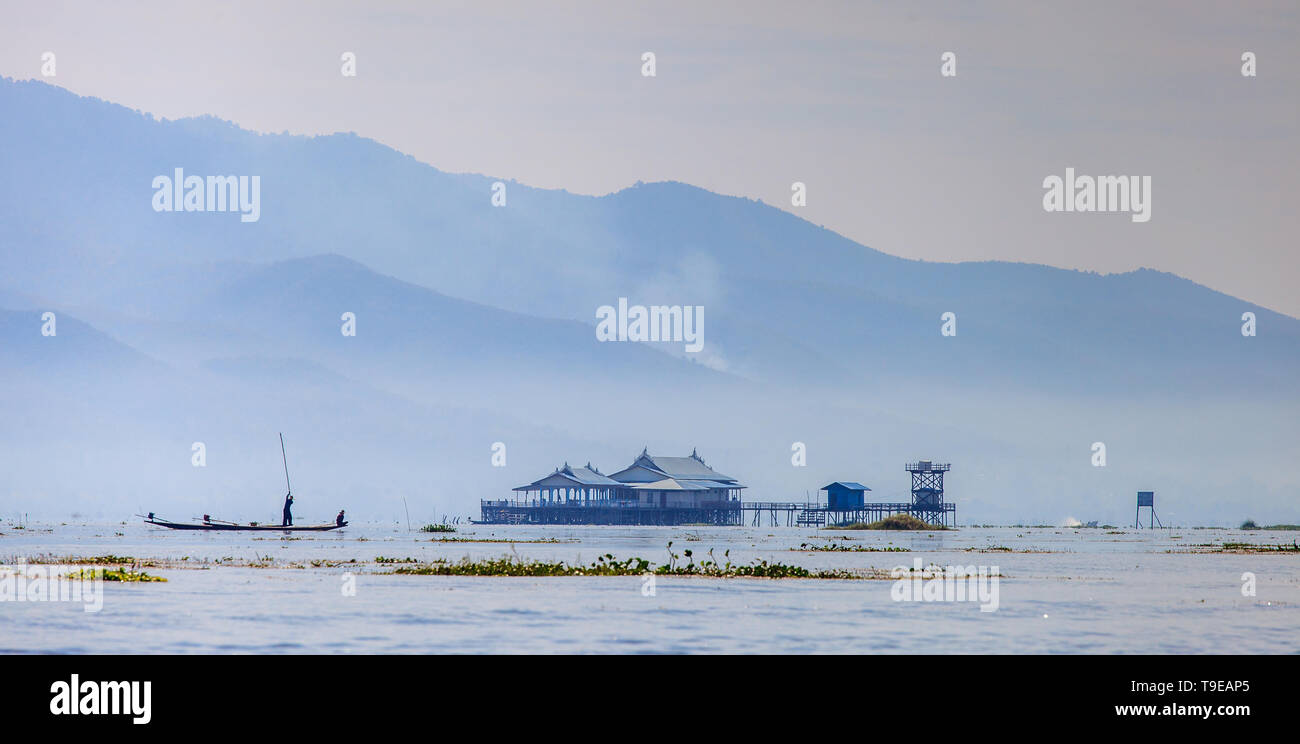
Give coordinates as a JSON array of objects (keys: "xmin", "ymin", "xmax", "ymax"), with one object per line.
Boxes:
[{"xmin": 0, "ymin": 79, "xmax": 1300, "ymax": 522}]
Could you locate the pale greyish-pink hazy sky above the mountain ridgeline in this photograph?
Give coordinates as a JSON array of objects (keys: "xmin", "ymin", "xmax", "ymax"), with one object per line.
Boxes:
[{"xmin": 0, "ymin": 0, "xmax": 1300, "ymax": 316}]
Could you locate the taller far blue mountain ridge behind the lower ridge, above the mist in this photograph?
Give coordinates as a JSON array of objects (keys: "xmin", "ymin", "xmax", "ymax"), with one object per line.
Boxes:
[{"xmin": 0, "ymin": 82, "xmax": 1300, "ymax": 393}]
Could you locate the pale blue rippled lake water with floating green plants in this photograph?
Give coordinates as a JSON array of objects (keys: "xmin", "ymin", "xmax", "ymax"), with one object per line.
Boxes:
[{"xmin": 0, "ymin": 523, "xmax": 1300, "ymax": 654}]
